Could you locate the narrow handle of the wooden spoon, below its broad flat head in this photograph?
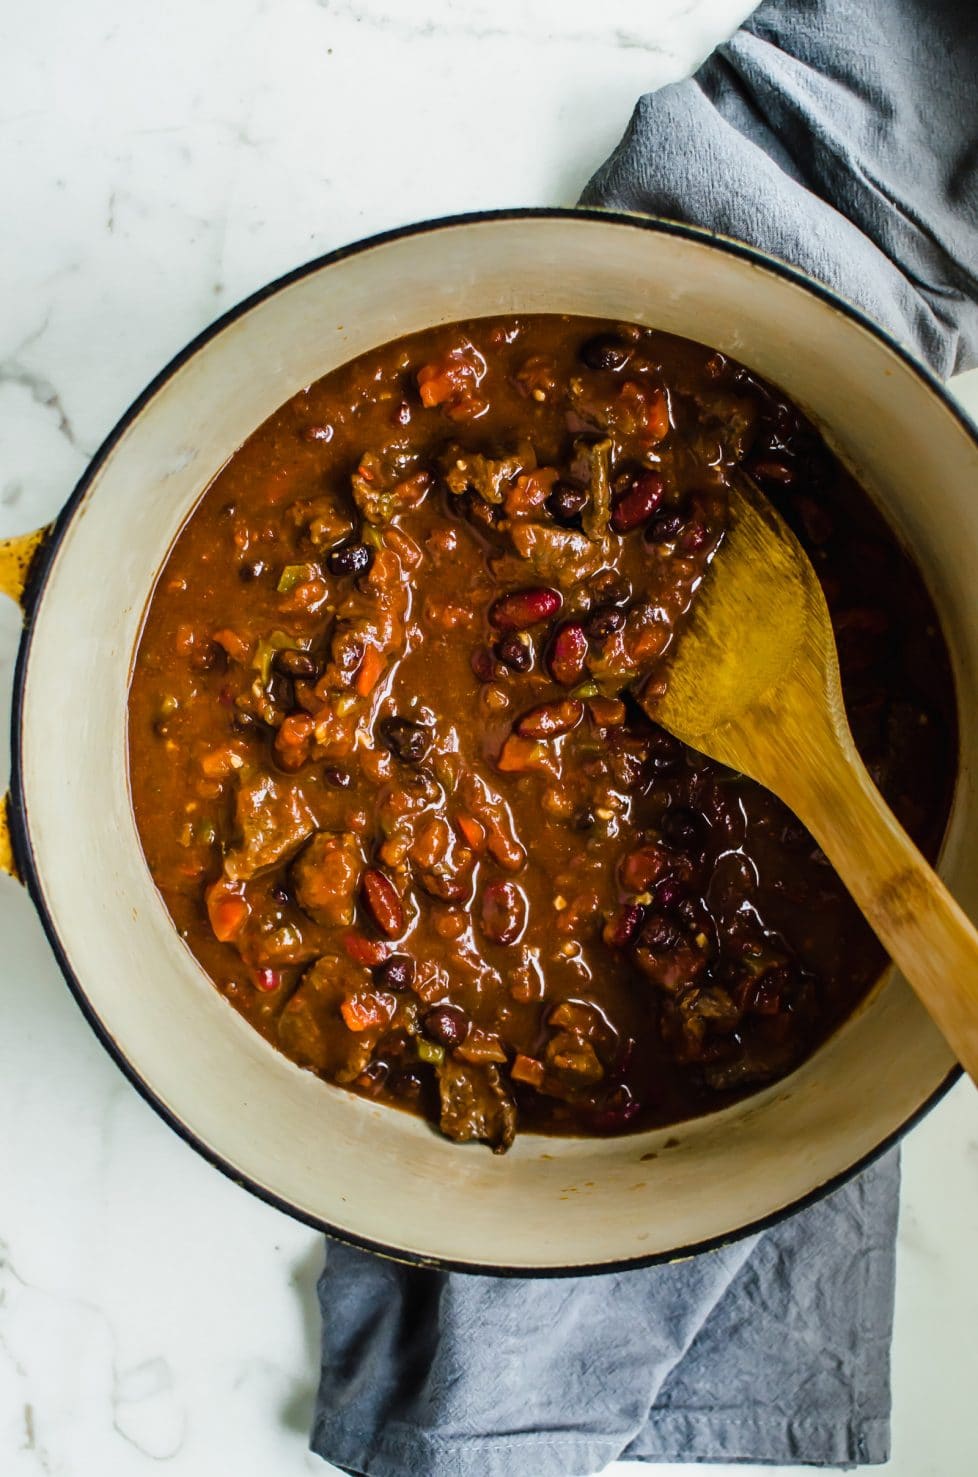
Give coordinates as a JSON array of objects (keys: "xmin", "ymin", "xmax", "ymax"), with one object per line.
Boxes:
[{"xmin": 783, "ymin": 714, "xmax": 978, "ymax": 1084}]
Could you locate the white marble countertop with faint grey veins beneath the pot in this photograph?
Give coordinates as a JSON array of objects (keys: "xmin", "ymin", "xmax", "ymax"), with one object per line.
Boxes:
[{"xmin": 0, "ymin": 0, "xmax": 978, "ymax": 1477}]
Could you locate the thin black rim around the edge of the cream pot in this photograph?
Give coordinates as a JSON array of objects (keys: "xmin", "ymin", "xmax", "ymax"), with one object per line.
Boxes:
[{"xmin": 7, "ymin": 207, "xmax": 978, "ymax": 1278}]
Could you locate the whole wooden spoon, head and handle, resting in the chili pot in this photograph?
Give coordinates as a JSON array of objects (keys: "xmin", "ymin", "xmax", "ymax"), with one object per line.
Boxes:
[{"xmin": 641, "ymin": 477, "xmax": 978, "ymax": 1083}]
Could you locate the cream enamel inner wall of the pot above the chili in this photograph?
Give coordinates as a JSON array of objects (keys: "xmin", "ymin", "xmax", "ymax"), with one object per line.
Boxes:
[{"xmin": 22, "ymin": 217, "xmax": 978, "ymax": 1270}]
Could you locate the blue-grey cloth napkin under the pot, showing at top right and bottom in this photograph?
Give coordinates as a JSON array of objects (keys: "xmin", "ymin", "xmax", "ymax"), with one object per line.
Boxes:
[{"xmin": 312, "ymin": 0, "xmax": 978, "ymax": 1477}]
